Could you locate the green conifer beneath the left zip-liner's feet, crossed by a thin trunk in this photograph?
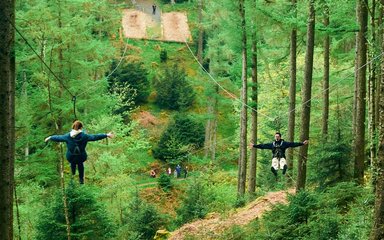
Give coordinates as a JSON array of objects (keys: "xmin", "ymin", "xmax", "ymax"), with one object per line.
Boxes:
[{"xmin": 37, "ymin": 181, "xmax": 115, "ymax": 239}]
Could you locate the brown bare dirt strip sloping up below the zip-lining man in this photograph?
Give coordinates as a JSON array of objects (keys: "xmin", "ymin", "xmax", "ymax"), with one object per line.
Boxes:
[{"xmin": 168, "ymin": 189, "xmax": 295, "ymax": 240}]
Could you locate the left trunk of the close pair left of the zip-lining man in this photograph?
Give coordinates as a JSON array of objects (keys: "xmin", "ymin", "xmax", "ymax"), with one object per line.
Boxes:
[{"xmin": 237, "ymin": 0, "xmax": 247, "ymax": 197}]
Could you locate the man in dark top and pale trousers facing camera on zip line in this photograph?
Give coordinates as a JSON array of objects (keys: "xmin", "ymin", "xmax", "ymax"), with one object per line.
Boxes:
[{"xmin": 250, "ymin": 132, "xmax": 308, "ymax": 177}]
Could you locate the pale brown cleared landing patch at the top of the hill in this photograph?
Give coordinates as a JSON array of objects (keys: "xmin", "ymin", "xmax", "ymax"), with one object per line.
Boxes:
[{"xmin": 122, "ymin": 0, "xmax": 192, "ymax": 42}]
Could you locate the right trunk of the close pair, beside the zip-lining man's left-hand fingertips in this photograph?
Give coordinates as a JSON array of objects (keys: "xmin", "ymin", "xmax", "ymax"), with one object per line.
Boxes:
[{"xmin": 248, "ymin": 0, "xmax": 257, "ymax": 194}]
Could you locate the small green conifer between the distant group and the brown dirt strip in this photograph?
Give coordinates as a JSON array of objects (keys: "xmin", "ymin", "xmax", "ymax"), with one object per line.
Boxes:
[{"xmin": 176, "ymin": 180, "xmax": 211, "ymax": 226}]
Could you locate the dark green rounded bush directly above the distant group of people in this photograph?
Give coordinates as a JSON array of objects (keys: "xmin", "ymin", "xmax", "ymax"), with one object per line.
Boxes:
[{"xmin": 153, "ymin": 114, "xmax": 205, "ymax": 164}]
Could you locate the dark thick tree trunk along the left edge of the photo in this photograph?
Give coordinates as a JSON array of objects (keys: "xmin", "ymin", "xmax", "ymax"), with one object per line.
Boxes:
[{"xmin": 0, "ymin": 0, "xmax": 15, "ymax": 240}]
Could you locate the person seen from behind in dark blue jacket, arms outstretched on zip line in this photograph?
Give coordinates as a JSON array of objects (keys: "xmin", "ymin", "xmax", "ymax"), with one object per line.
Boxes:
[{"xmin": 45, "ymin": 120, "xmax": 114, "ymax": 184}]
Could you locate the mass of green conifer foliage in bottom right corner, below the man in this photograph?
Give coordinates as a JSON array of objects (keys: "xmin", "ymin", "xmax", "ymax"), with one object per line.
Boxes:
[{"xmin": 243, "ymin": 183, "xmax": 373, "ymax": 240}]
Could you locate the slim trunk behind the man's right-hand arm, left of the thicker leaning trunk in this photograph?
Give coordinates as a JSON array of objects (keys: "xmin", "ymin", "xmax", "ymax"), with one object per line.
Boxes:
[{"xmin": 287, "ymin": 0, "xmax": 297, "ymax": 184}]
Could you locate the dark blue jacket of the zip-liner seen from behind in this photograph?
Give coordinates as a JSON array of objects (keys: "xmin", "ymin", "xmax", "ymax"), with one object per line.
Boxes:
[{"xmin": 50, "ymin": 132, "xmax": 107, "ymax": 162}]
